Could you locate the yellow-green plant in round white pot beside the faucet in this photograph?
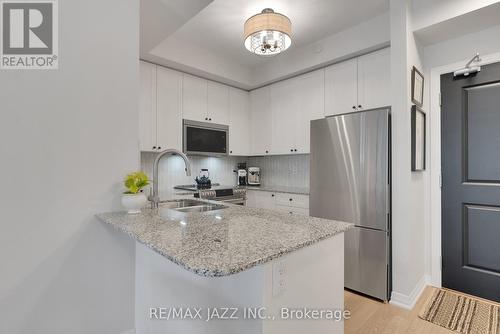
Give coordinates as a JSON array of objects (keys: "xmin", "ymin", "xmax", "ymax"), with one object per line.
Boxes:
[{"xmin": 122, "ymin": 172, "xmax": 150, "ymax": 214}]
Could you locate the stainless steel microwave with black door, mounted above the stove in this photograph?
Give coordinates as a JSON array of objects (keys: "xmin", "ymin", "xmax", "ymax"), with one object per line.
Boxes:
[{"xmin": 182, "ymin": 119, "xmax": 229, "ymax": 156}]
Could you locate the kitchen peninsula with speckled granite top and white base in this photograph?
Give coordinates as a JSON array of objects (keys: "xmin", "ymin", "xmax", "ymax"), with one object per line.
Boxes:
[{"xmin": 98, "ymin": 201, "xmax": 351, "ymax": 334}]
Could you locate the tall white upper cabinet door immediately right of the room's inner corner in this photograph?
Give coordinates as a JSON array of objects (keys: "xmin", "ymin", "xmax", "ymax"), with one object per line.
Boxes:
[{"xmin": 250, "ymin": 86, "xmax": 273, "ymax": 155}]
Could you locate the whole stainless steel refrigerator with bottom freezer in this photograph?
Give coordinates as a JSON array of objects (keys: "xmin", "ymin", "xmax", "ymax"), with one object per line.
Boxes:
[{"xmin": 309, "ymin": 108, "xmax": 391, "ymax": 301}]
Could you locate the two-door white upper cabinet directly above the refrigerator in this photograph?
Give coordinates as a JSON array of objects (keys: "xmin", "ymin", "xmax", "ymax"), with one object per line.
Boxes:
[{"xmin": 325, "ymin": 48, "xmax": 391, "ymax": 116}]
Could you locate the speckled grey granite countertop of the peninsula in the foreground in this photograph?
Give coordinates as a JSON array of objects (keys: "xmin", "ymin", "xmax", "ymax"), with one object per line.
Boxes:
[{"xmin": 97, "ymin": 201, "xmax": 353, "ymax": 277}]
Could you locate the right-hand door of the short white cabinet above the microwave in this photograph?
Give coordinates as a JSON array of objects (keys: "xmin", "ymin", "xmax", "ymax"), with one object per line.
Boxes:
[{"xmin": 207, "ymin": 81, "xmax": 229, "ymax": 124}]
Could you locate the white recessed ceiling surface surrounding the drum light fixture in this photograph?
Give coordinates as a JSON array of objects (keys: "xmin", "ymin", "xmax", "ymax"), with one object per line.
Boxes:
[{"xmin": 162, "ymin": 0, "xmax": 389, "ymax": 67}]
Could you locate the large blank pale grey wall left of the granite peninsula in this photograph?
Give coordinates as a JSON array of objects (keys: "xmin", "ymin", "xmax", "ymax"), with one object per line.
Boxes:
[{"xmin": 0, "ymin": 0, "xmax": 139, "ymax": 334}]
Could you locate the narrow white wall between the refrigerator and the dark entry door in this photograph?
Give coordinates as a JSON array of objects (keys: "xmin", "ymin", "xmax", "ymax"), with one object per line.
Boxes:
[{"xmin": 391, "ymin": 0, "xmax": 428, "ymax": 308}]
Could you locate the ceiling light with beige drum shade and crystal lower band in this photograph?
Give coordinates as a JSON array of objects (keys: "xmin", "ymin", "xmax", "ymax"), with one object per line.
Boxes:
[{"xmin": 245, "ymin": 8, "xmax": 292, "ymax": 56}]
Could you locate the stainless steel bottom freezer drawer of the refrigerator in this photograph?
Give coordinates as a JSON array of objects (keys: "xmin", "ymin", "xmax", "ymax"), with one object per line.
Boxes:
[{"xmin": 344, "ymin": 227, "xmax": 389, "ymax": 300}]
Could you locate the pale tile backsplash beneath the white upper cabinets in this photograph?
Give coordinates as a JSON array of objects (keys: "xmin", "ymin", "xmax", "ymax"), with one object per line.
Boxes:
[{"xmin": 141, "ymin": 152, "xmax": 309, "ymax": 198}]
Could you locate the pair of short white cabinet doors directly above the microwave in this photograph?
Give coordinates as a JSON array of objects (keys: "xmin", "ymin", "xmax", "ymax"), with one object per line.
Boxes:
[{"xmin": 182, "ymin": 74, "xmax": 229, "ymax": 125}]
